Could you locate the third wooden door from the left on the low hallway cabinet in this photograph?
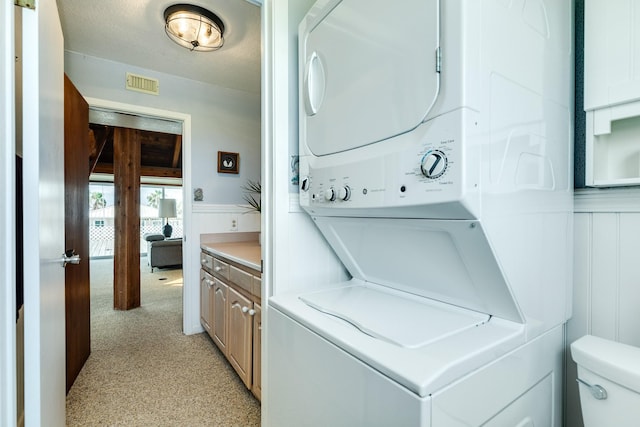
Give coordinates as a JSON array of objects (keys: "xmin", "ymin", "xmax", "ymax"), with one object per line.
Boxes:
[{"xmin": 227, "ymin": 288, "xmax": 253, "ymax": 388}]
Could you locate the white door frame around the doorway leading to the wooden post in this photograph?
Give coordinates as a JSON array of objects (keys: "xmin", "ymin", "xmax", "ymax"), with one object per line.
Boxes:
[{"xmin": 85, "ymin": 97, "xmax": 201, "ymax": 335}]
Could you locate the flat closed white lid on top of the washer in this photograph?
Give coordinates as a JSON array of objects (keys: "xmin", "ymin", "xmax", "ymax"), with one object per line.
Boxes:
[{"xmin": 300, "ymin": 285, "xmax": 489, "ymax": 348}]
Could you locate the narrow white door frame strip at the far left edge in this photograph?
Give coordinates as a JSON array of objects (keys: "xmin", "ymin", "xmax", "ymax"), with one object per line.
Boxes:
[{"xmin": 0, "ymin": 1, "xmax": 17, "ymax": 426}]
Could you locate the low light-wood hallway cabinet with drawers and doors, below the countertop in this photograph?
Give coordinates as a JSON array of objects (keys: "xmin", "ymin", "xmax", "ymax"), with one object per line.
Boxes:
[{"xmin": 200, "ymin": 246, "xmax": 262, "ymax": 399}]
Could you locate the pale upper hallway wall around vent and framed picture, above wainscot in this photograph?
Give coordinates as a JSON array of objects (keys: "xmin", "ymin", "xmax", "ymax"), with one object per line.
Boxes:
[{"xmin": 65, "ymin": 51, "xmax": 260, "ymax": 204}]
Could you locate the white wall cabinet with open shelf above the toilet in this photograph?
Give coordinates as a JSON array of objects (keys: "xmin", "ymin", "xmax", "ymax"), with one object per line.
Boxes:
[{"xmin": 584, "ymin": 0, "xmax": 640, "ymax": 187}]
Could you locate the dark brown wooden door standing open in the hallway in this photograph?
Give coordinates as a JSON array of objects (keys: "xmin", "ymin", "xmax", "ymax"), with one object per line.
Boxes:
[{"xmin": 64, "ymin": 75, "xmax": 91, "ymax": 392}]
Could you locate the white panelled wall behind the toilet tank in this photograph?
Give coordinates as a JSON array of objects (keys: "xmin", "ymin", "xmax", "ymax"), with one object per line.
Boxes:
[{"xmin": 565, "ymin": 188, "xmax": 640, "ymax": 427}]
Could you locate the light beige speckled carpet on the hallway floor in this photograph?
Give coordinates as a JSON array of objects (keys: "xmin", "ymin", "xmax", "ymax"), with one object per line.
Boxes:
[{"xmin": 67, "ymin": 258, "xmax": 260, "ymax": 427}]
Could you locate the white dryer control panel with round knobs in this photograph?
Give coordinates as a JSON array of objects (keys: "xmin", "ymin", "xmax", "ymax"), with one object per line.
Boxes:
[{"xmin": 299, "ymin": 109, "xmax": 480, "ymax": 219}]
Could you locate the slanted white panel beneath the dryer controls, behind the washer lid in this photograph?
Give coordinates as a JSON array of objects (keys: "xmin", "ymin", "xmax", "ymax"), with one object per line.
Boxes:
[{"xmin": 313, "ymin": 216, "xmax": 524, "ymax": 323}]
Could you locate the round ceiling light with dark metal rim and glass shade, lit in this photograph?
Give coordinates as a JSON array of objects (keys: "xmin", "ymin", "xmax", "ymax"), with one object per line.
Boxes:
[{"xmin": 164, "ymin": 4, "xmax": 224, "ymax": 52}]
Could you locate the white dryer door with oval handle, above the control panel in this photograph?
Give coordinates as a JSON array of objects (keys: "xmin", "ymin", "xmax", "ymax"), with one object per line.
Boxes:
[{"xmin": 299, "ymin": 0, "xmax": 439, "ymax": 156}]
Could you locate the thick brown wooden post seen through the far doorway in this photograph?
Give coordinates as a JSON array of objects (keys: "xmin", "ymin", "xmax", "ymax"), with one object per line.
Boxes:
[{"xmin": 113, "ymin": 128, "xmax": 141, "ymax": 310}]
